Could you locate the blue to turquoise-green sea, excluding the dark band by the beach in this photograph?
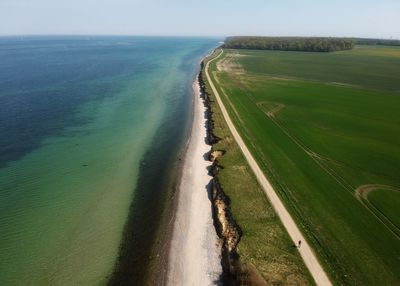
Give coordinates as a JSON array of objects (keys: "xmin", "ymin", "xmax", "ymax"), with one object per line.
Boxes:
[{"xmin": 0, "ymin": 37, "xmax": 217, "ymax": 285}]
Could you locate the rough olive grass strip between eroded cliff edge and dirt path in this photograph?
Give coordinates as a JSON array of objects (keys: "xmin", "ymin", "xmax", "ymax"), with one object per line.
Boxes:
[{"xmin": 203, "ymin": 52, "xmax": 313, "ymax": 285}]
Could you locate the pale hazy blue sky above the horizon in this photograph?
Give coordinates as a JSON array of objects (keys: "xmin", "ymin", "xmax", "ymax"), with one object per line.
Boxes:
[{"xmin": 0, "ymin": 0, "xmax": 400, "ymax": 39}]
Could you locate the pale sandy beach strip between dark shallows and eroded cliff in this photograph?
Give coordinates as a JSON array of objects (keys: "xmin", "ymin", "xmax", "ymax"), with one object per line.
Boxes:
[{"xmin": 167, "ymin": 80, "xmax": 222, "ymax": 285}]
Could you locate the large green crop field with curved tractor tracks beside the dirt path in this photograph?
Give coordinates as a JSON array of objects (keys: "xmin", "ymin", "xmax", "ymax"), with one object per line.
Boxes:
[{"xmin": 210, "ymin": 46, "xmax": 400, "ymax": 285}]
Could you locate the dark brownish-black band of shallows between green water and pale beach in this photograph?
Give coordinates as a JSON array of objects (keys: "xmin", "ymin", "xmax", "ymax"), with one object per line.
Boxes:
[{"xmin": 107, "ymin": 79, "xmax": 192, "ymax": 286}]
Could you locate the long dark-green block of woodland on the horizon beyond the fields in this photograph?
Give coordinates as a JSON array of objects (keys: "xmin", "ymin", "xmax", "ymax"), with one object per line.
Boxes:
[{"xmin": 222, "ymin": 37, "xmax": 355, "ymax": 52}]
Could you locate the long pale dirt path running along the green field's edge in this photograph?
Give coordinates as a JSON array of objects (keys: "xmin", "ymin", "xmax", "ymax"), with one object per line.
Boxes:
[{"xmin": 205, "ymin": 52, "xmax": 332, "ymax": 286}]
